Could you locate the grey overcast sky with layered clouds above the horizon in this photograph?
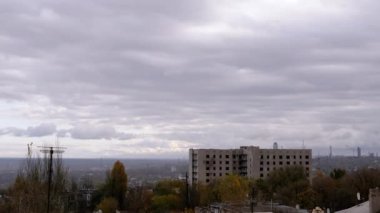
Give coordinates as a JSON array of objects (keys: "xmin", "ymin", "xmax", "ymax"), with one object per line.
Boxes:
[{"xmin": 0, "ymin": 0, "xmax": 380, "ymax": 158}]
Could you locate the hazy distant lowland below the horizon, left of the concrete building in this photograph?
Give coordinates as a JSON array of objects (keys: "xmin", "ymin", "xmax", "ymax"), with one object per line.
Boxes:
[{"xmin": 0, "ymin": 158, "xmax": 187, "ymax": 189}]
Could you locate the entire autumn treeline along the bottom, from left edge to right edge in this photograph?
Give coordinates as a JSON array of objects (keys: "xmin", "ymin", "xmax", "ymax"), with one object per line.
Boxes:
[{"xmin": 0, "ymin": 152, "xmax": 380, "ymax": 213}]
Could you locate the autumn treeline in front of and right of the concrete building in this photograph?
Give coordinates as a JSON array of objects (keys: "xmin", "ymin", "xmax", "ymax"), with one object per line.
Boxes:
[{"xmin": 195, "ymin": 167, "xmax": 380, "ymax": 212}]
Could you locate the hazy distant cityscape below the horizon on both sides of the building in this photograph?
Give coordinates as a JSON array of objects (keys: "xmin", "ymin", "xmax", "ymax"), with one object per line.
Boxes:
[{"xmin": 0, "ymin": 150, "xmax": 380, "ymax": 189}]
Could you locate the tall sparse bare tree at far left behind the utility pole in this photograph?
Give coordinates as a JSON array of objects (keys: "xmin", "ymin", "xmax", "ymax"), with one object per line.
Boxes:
[{"xmin": 9, "ymin": 144, "xmax": 69, "ymax": 213}]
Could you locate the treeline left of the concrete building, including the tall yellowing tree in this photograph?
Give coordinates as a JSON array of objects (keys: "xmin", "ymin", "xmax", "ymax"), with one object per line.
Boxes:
[{"xmin": 0, "ymin": 153, "xmax": 193, "ymax": 213}]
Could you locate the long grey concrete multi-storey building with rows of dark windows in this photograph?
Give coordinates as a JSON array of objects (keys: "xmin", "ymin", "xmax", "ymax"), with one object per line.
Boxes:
[{"xmin": 188, "ymin": 144, "xmax": 312, "ymax": 184}]
